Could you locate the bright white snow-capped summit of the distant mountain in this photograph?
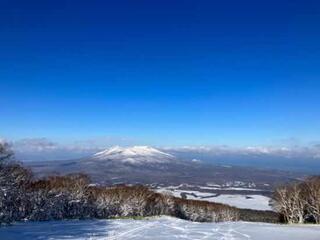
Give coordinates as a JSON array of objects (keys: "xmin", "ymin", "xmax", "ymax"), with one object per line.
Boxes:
[{"xmin": 92, "ymin": 146, "xmax": 175, "ymax": 164}]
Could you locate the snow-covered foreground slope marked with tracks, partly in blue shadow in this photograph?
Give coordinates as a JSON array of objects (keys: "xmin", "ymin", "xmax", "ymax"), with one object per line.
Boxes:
[{"xmin": 0, "ymin": 216, "xmax": 320, "ymax": 240}]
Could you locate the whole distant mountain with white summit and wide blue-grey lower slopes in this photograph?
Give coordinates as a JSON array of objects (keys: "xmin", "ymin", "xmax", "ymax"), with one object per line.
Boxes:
[{"xmin": 28, "ymin": 146, "xmax": 303, "ymax": 189}]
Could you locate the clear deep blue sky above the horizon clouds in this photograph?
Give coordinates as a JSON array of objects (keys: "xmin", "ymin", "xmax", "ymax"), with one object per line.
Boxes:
[{"xmin": 0, "ymin": 0, "xmax": 320, "ymax": 145}]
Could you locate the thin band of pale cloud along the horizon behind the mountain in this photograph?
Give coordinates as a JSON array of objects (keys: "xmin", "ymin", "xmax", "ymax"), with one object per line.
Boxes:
[{"xmin": 2, "ymin": 137, "xmax": 320, "ymax": 160}]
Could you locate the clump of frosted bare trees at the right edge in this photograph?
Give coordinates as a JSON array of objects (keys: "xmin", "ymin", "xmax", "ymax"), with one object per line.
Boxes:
[{"xmin": 273, "ymin": 176, "xmax": 320, "ymax": 224}]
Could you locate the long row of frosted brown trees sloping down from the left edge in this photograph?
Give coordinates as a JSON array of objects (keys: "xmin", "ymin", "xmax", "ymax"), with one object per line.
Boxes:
[{"xmin": 0, "ymin": 164, "xmax": 279, "ymax": 223}]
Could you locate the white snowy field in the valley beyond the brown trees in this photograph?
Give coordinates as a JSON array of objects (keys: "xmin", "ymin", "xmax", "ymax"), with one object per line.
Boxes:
[{"xmin": 155, "ymin": 188, "xmax": 272, "ymax": 211}]
